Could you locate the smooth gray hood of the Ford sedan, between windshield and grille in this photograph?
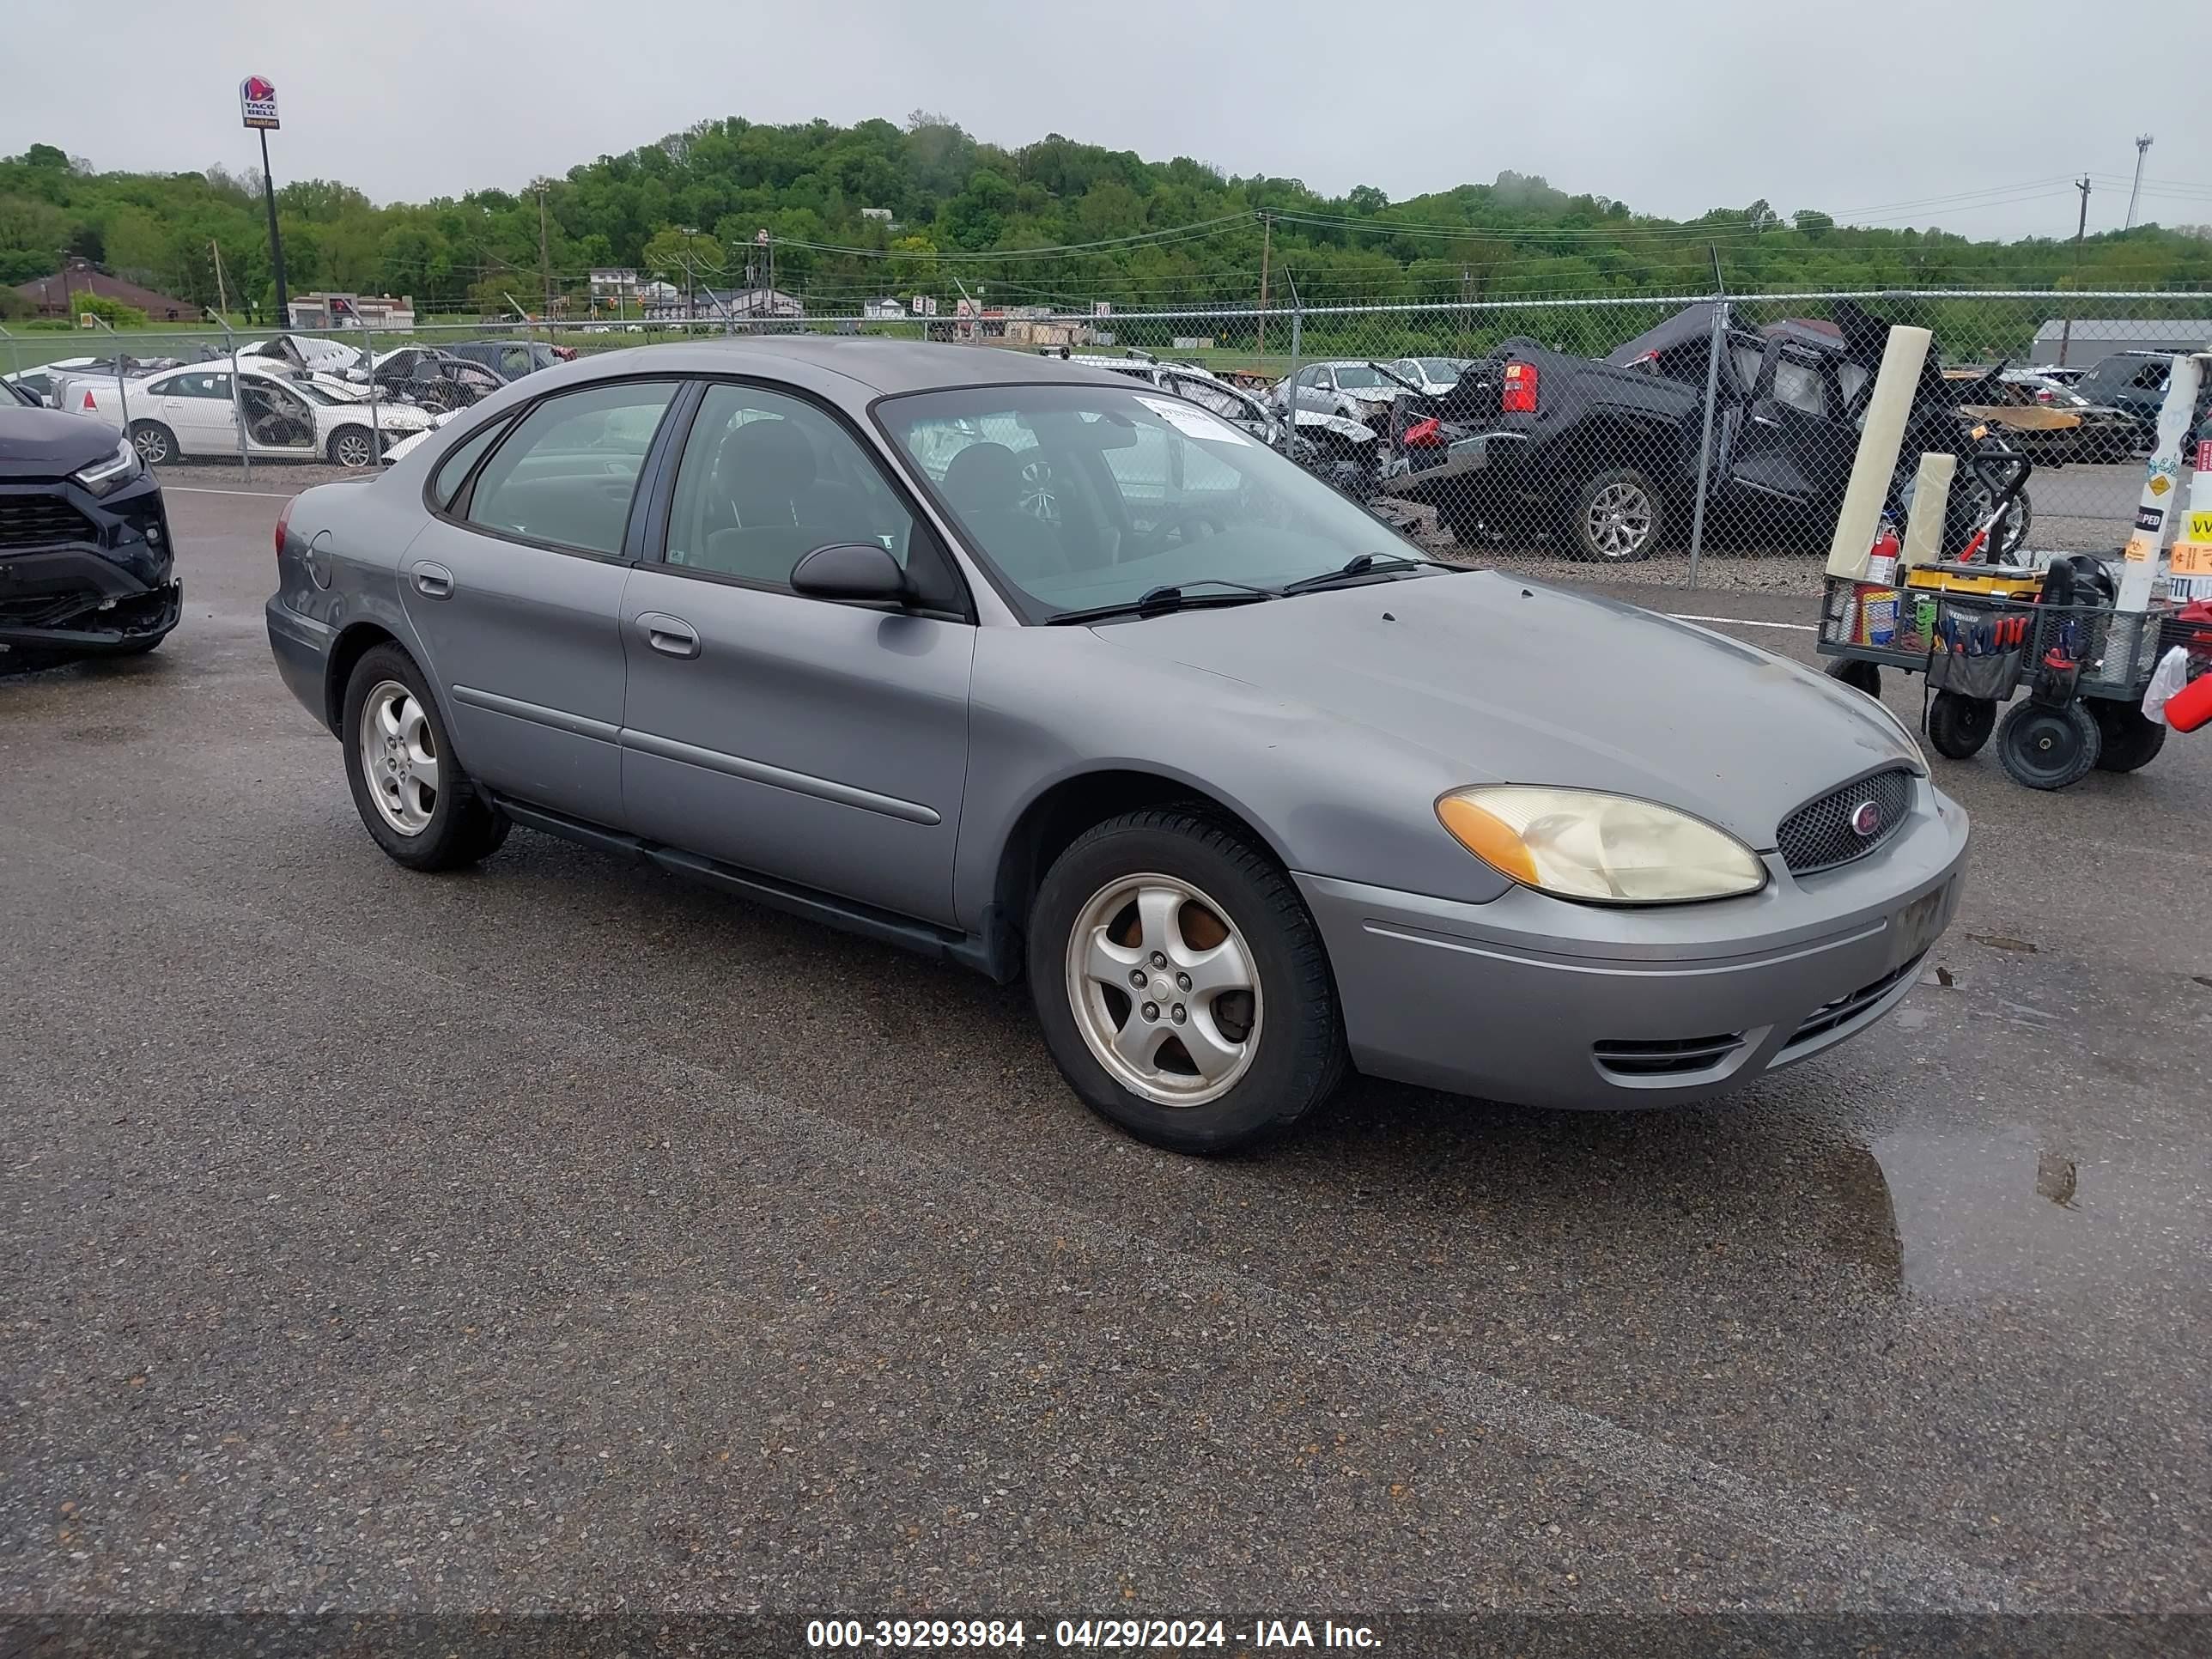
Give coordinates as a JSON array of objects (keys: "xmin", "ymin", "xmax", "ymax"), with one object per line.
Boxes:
[{"xmin": 1095, "ymin": 573, "xmax": 1913, "ymax": 852}]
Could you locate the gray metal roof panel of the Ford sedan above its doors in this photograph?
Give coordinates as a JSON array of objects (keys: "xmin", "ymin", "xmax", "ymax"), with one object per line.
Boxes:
[{"xmin": 550, "ymin": 334, "xmax": 1128, "ymax": 394}]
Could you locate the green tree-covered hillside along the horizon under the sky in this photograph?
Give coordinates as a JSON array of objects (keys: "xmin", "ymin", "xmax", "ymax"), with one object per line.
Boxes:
[{"xmin": 0, "ymin": 112, "xmax": 2212, "ymax": 325}]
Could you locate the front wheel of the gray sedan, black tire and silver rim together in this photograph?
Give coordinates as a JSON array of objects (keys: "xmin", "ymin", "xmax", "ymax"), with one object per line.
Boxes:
[{"xmin": 1029, "ymin": 807, "xmax": 1347, "ymax": 1152}]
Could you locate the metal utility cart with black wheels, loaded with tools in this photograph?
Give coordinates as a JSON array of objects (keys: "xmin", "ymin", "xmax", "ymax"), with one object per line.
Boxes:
[{"xmin": 1818, "ymin": 564, "xmax": 2212, "ymax": 790}]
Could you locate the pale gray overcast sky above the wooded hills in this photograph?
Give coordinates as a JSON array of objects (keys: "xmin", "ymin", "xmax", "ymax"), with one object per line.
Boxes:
[{"xmin": 13, "ymin": 0, "xmax": 2212, "ymax": 237}]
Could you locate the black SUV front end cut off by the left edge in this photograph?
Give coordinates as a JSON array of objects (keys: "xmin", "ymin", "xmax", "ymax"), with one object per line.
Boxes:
[{"xmin": 0, "ymin": 400, "xmax": 184, "ymax": 668}]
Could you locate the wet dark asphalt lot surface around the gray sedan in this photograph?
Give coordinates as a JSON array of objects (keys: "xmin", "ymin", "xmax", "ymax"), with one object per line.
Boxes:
[{"xmin": 0, "ymin": 484, "xmax": 2212, "ymax": 1650}]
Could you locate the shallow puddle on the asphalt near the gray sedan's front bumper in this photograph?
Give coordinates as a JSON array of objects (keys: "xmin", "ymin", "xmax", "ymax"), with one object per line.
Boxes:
[{"xmin": 1858, "ymin": 1126, "xmax": 2212, "ymax": 1301}]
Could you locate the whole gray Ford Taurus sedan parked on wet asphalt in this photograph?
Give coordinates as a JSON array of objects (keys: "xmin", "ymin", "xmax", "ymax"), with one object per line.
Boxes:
[{"xmin": 268, "ymin": 337, "xmax": 1966, "ymax": 1151}]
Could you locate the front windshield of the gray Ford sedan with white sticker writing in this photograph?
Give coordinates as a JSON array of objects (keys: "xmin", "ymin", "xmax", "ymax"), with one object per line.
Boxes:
[{"xmin": 878, "ymin": 385, "xmax": 1422, "ymax": 622}]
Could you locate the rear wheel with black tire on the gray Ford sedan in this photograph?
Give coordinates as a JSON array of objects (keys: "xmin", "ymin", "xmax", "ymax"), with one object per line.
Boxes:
[{"xmin": 338, "ymin": 646, "xmax": 511, "ymax": 869}]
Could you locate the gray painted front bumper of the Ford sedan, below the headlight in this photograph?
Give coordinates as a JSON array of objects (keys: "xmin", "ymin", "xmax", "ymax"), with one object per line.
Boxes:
[{"xmin": 1297, "ymin": 779, "xmax": 1966, "ymax": 1109}]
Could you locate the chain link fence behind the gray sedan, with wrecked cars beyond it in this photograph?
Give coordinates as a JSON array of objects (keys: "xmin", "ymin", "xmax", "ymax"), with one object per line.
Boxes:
[{"xmin": 0, "ymin": 289, "xmax": 2212, "ymax": 592}]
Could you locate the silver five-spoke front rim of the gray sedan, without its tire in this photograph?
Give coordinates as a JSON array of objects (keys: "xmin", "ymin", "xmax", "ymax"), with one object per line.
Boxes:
[{"xmin": 1066, "ymin": 874, "xmax": 1261, "ymax": 1106}]
